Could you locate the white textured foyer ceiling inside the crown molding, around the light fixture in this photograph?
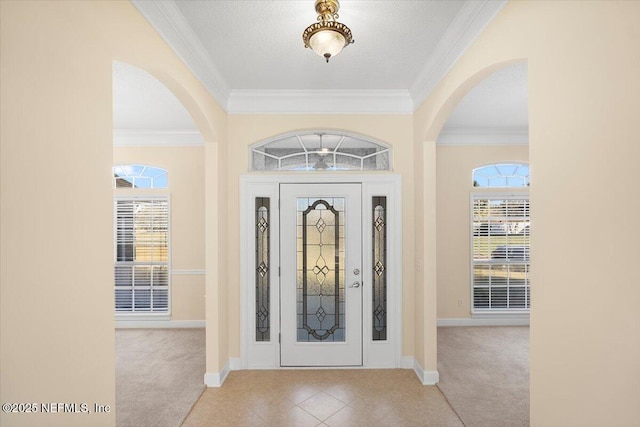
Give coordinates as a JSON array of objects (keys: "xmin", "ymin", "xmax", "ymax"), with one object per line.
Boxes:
[{"xmin": 176, "ymin": 0, "xmax": 464, "ymax": 90}]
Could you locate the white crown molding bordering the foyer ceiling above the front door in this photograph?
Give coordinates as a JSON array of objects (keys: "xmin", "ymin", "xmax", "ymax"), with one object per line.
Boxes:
[{"xmin": 131, "ymin": 0, "xmax": 507, "ymax": 114}]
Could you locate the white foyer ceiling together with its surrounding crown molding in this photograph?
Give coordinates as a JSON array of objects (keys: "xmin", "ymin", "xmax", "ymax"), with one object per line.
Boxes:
[{"xmin": 131, "ymin": 0, "xmax": 506, "ymax": 113}]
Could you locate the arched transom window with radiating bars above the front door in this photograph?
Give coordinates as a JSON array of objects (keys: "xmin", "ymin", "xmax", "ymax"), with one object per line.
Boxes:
[{"xmin": 249, "ymin": 131, "xmax": 391, "ymax": 171}]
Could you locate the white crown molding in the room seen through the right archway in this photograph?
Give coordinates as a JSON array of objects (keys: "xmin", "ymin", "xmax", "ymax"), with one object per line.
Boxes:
[{"xmin": 436, "ymin": 127, "xmax": 529, "ymax": 145}]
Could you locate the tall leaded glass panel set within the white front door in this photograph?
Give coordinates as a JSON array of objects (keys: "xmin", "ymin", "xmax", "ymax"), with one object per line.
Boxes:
[{"xmin": 296, "ymin": 197, "xmax": 345, "ymax": 342}]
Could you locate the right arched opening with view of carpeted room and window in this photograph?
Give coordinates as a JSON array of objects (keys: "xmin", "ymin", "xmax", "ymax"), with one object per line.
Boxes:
[{"xmin": 429, "ymin": 62, "xmax": 535, "ymax": 424}]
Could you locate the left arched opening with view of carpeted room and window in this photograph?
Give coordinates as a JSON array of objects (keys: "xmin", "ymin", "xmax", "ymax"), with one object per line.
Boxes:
[{"xmin": 113, "ymin": 61, "xmax": 217, "ymax": 422}]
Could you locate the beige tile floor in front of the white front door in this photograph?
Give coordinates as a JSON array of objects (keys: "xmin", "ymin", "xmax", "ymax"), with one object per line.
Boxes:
[{"xmin": 182, "ymin": 369, "xmax": 464, "ymax": 427}]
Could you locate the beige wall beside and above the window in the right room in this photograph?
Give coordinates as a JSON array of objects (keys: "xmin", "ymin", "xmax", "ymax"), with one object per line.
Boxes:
[{"xmin": 436, "ymin": 145, "xmax": 529, "ymax": 319}]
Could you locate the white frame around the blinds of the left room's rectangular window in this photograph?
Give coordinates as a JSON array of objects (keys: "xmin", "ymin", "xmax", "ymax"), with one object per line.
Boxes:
[{"xmin": 112, "ymin": 196, "xmax": 172, "ymax": 320}]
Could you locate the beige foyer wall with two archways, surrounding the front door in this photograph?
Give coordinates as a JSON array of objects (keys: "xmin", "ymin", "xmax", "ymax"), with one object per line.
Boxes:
[{"xmin": 0, "ymin": 1, "xmax": 640, "ymax": 427}]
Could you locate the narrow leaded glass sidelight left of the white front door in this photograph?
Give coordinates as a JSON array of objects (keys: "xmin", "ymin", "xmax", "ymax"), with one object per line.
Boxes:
[{"xmin": 255, "ymin": 197, "xmax": 271, "ymax": 341}]
